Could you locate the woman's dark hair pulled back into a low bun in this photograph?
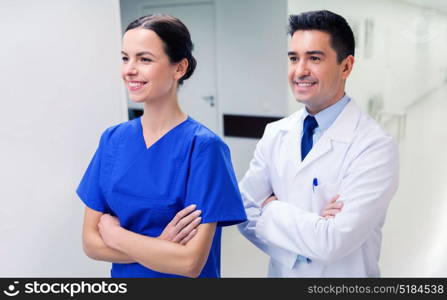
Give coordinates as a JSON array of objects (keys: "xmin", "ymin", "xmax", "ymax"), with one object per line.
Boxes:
[{"xmin": 125, "ymin": 14, "xmax": 197, "ymax": 84}]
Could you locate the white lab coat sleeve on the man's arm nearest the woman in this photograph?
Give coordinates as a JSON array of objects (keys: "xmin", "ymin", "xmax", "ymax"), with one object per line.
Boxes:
[{"xmin": 238, "ymin": 125, "xmax": 297, "ymax": 269}]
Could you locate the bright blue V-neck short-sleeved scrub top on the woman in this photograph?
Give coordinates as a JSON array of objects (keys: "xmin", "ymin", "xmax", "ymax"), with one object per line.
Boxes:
[{"xmin": 76, "ymin": 117, "xmax": 247, "ymax": 277}]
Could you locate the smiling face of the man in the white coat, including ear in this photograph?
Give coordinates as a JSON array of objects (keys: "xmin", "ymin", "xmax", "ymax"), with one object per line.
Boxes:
[{"xmin": 288, "ymin": 30, "xmax": 354, "ymax": 114}]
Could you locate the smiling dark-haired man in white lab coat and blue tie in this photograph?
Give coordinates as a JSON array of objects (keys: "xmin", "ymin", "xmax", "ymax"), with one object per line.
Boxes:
[{"xmin": 239, "ymin": 11, "xmax": 398, "ymax": 277}]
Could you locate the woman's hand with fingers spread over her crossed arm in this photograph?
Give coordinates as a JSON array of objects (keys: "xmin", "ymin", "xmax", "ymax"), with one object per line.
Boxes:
[{"xmin": 159, "ymin": 204, "xmax": 202, "ymax": 245}]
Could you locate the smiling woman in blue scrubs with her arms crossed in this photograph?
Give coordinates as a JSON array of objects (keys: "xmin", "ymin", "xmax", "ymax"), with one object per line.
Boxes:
[{"xmin": 77, "ymin": 15, "xmax": 246, "ymax": 277}]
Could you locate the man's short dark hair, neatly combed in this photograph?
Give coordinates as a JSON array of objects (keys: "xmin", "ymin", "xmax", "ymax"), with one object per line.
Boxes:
[{"xmin": 288, "ymin": 10, "xmax": 355, "ymax": 63}]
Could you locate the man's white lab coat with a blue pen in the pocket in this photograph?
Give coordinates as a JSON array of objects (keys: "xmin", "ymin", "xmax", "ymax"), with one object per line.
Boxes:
[{"xmin": 238, "ymin": 100, "xmax": 398, "ymax": 277}]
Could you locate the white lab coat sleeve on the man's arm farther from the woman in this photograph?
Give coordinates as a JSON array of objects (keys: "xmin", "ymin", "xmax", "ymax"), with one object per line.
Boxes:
[{"xmin": 254, "ymin": 137, "xmax": 398, "ymax": 264}]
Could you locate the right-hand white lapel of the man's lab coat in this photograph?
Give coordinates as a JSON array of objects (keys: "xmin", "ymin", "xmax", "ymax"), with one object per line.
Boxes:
[{"xmin": 297, "ymin": 100, "xmax": 360, "ymax": 173}]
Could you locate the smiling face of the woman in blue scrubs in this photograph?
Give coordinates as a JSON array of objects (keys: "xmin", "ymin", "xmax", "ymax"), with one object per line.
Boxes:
[{"xmin": 121, "ymin": 28, "xmax": 179, "ymax": 102}]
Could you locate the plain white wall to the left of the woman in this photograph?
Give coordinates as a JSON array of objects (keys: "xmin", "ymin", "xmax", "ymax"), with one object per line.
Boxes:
[{"xmin": 0, "ymin": 0, "xmax": 127, "ymax": 277}]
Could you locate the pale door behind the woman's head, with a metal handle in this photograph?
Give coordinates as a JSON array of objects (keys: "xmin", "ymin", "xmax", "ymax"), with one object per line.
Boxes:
[{"xmin": 140, "ymin": 2, "xmax": 219, "ymax": 133}]
